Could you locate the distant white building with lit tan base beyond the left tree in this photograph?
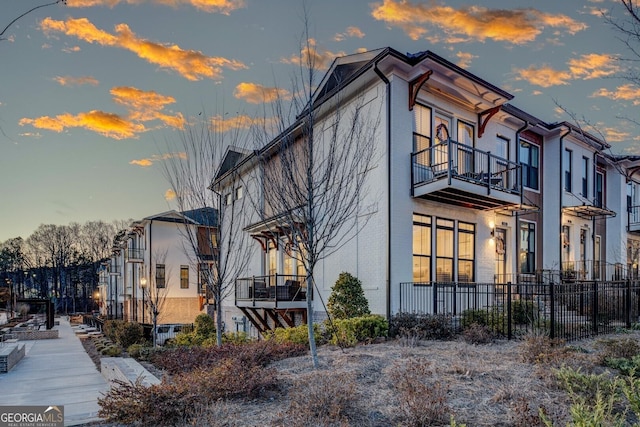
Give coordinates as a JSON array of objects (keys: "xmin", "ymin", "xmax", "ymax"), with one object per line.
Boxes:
[{"xmin": 99, "ymin": 208, "xmax": 216, "ymax": 323}]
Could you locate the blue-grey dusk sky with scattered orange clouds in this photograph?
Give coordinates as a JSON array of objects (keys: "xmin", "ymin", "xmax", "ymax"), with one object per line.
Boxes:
[{"xmin": 0, "ymin": 0, "xmax": 640, "ymax": 242}]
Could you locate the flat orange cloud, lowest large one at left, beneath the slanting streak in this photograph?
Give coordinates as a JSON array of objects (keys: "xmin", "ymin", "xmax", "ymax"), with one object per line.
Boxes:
[{"xmin": 18, "ymin": 110, "xmax": 145, "ymax": 139}]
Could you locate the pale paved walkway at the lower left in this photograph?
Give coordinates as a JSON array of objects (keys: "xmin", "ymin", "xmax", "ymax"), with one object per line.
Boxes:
[{"xmin": 0, "ymin": 317, "xmax": 109, "ymax": 426}]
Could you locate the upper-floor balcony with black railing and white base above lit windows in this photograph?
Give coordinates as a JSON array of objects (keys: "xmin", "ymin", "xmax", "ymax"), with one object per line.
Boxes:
[{"xmin": 411, "ymin": 140, "xmax": 522, "ymax": 210}]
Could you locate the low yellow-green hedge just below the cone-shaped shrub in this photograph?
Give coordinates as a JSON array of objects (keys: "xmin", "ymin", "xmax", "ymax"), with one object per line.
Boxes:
[{"xmin": 326, "ymin": 314, "xmax": 389, "ymax": 347}]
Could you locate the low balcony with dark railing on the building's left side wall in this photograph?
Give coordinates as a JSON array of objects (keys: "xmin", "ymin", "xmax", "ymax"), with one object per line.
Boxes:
[{"xmin": 236, "ymin": 274, "xmax": 307, "ymax": 309}]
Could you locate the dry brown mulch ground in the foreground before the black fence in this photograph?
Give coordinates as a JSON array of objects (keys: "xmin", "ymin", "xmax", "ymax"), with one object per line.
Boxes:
[{"xmin": 79, "ymin": 332, "xmax": 640, "ymax": 426}]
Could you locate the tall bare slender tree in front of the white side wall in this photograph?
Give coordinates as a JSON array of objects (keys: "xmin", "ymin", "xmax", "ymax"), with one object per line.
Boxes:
[{"xmin": 251, "ymin": 22, "xmax": 380, "ymax": 367}]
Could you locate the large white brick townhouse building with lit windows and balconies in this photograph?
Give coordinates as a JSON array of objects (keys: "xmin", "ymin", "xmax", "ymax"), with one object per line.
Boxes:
[{"xmin": 213, "ymin": 48, "xmax": 640, "ymax": 338}]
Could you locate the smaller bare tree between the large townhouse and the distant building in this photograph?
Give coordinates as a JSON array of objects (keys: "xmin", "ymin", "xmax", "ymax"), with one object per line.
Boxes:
[{"xmin": 164, "ymin": 114, "xmax": 252, "ymax": 345}]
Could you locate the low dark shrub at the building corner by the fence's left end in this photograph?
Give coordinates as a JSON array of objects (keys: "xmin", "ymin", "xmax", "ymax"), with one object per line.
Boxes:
[{"xmin": 388, "ymin": 312, "xmax": 455, "ymax": 340}]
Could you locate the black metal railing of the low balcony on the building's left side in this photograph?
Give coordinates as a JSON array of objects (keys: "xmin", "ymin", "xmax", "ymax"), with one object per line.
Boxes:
[{"xmin": 236, "ymin": 274, "xmax": 307, "ymax": 302}]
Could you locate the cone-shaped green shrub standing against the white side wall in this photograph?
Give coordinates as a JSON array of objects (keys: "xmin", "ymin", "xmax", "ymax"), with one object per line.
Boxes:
[{"xmin": 327, "ymin": 273, "xmax": 371, "ymax": 319}]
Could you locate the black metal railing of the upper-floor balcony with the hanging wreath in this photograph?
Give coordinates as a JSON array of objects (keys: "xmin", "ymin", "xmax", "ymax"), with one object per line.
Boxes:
[{"xmin": 411, "ymin": 135, "xmax": 522, "ymax": 194}]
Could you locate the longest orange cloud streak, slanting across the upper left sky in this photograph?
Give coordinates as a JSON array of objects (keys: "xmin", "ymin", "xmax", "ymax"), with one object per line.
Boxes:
[{"xmin": 40, "ymin": 18, "xmax": 247, "ymax": 81}]
